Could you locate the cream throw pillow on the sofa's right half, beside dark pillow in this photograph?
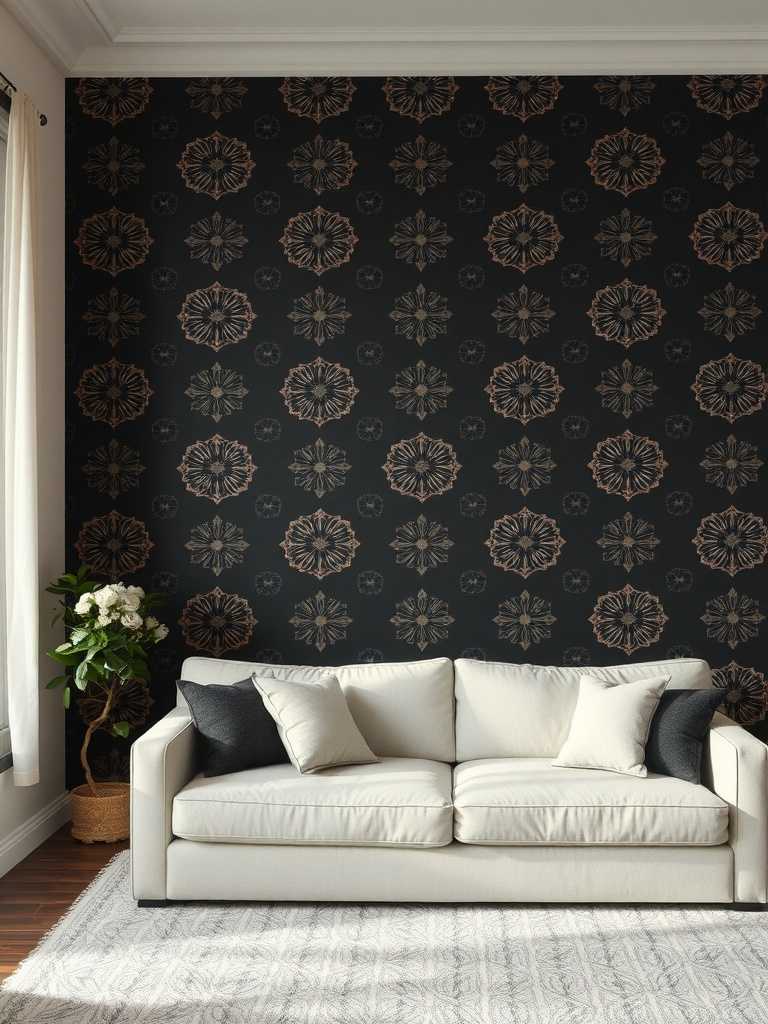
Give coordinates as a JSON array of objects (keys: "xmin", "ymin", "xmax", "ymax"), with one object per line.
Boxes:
[{"xmin": 552, "ymin": 676, "xmax": 670, "ymax": 777}]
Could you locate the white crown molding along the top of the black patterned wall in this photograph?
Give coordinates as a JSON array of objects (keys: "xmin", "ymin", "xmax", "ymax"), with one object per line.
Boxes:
[{"xmin": 0, "ymin": 0, "xmax": 768, "ymax": 77}]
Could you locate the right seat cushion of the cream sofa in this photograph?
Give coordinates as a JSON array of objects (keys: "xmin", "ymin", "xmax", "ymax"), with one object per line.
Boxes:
[{"xmin": 454, "ymin": 758, "xmax": 728, "ymax": 846}]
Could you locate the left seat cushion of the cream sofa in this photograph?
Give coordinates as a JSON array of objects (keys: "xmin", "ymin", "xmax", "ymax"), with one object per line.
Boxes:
[{"xmin": 173, "ymin": 758, "xmax": 453, "ymax": 847}]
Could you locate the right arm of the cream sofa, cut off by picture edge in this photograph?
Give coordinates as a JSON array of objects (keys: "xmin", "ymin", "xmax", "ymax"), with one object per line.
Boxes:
[{"xmin": 709, "ymin": 714, "xmax": 768, "ymax": 903}]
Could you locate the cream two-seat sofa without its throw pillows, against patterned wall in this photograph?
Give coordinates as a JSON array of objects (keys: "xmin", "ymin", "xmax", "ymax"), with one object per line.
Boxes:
[{"xmin": 131, "ymin": 657, "xmax": 768, "ymax": 905}]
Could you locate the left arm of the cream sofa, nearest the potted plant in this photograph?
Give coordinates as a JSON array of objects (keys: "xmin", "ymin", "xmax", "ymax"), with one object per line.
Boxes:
[{"xmin": 131, "ymin": 708, "xmax": 195, "ymax": 900}]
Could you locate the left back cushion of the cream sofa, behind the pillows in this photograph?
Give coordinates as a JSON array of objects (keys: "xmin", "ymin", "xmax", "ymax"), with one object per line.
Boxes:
[{"xmin": 177, "ymin": 657, "xmax": 456, "ymax": 761}]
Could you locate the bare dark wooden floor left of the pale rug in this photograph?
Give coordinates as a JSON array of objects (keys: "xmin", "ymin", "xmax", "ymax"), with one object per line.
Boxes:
[{"xmin": 0, "ymin": 826, "xmax": 128, "ymax": 981}]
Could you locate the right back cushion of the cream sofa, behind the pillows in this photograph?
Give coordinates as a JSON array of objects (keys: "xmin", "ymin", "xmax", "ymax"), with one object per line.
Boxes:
[{"xmin": 454, "ymin": 657, "xmax": 712, "ymax": 761}]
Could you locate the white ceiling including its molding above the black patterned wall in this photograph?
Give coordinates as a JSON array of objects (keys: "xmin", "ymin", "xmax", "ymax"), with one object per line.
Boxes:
[{"xmin": 0, "ymin": 0, "xmax": 768, "ymax": 75}]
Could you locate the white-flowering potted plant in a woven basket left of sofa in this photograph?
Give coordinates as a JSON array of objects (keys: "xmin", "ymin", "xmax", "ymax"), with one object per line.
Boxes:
[{"xmin": 47, "ymin": 565, "xmax": 168, "ymax": 843}]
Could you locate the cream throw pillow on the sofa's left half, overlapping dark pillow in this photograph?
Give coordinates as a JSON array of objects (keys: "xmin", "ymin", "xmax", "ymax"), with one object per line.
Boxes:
[{"xmin": 251, "ymin": 674, "xmax": 379, "ymax": 774}]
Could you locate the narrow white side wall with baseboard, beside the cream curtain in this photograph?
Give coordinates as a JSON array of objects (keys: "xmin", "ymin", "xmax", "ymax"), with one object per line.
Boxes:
[{"xmin": 0, "ymin": 7, "xmax": 68, "ymax": 876}]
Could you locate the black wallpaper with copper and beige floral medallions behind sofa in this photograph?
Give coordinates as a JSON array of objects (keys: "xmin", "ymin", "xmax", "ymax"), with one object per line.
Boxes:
[{"xmin": 68, "ymin": 75, "xmax": 768, "ymax": 775}]
